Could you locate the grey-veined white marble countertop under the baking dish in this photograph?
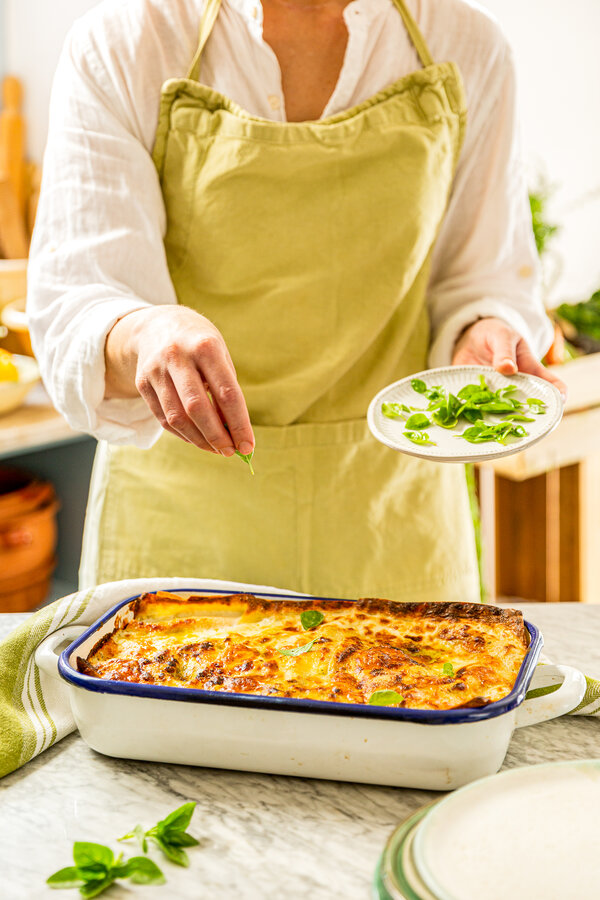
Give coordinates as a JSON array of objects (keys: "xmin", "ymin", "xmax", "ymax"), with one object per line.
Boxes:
[{"xmin": 0, "ymin": 603, "xmax": 600, "ymax": 900}]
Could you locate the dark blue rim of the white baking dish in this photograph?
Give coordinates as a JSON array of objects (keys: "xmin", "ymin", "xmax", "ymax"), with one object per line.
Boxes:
[{"xmin": 58, "ymin": 588, "xmax": 544, "ymax": 725}]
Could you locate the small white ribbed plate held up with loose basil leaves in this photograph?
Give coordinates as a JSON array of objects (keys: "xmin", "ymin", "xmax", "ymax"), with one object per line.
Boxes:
[{"xmin": 367, "ymin": 366, "xmax": 564, "ymax": 463}]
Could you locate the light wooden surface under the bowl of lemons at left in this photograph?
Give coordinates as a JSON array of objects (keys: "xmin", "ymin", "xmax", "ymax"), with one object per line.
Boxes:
[{"xmin": 0, "ymin": 386, "xmax": 87, "ymax": 459}]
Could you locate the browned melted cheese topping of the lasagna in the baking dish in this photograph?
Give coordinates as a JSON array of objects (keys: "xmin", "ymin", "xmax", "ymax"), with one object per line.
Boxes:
[{"xmin": 78, "ymin": 592, "xmax": 529, "ymax": 709}]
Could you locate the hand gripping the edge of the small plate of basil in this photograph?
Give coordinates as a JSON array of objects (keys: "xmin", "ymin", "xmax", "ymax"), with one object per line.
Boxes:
[{"xmin": 452, "ymin": 318, "xmax": 567, "ymax": 400}]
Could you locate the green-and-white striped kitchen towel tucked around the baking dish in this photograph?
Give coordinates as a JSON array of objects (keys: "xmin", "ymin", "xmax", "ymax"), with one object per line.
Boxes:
[{"xmin": 0, "ymin": 578, "xmax": 600, "ymax": 777}]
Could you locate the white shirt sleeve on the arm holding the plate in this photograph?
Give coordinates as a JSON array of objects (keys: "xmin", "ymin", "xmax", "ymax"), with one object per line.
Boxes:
[{"xmin": 428, "ymin": 40, "xmax": 552, "ymax": 366}]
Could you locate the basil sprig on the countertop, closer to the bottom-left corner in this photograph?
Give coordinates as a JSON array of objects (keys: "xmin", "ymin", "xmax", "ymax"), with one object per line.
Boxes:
[{"xmin": 46, "ymin": 841, "xmax": 166, "ymax": 898}]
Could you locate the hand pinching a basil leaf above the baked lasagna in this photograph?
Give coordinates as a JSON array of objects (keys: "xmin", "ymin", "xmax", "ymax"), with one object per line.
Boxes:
[{"xmin": 104, "ymin": 305, "xmax": 254, "ymax": 456}]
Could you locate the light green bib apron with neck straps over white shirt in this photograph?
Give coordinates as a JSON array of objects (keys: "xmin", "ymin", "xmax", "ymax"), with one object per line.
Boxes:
[{"xmin": 81, "ymin": 0, "xmax": 479, "ymax": 601}]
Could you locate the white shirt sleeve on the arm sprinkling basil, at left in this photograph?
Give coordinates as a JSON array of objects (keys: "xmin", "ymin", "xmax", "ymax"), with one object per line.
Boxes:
[{"xmin": 27, "ymin": 26, "xmax": 176, "ymax": 447}]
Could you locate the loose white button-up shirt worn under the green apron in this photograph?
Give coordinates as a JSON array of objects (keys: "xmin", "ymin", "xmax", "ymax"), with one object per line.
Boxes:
[{"xmin": 28, "ymin": 0, "xmax": 552, "ymax": 447}]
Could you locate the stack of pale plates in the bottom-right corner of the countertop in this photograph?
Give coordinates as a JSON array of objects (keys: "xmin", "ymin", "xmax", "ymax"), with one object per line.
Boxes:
[{"xmin": 373, "ymin": 759, "xmax": 600, "ymax": 900}]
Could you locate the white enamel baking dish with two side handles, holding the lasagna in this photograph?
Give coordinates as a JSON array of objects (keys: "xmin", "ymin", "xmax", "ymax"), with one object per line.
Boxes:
[{"xmin": 36, "ymin": 590, "xmax": 585, "ymax": 790}]
